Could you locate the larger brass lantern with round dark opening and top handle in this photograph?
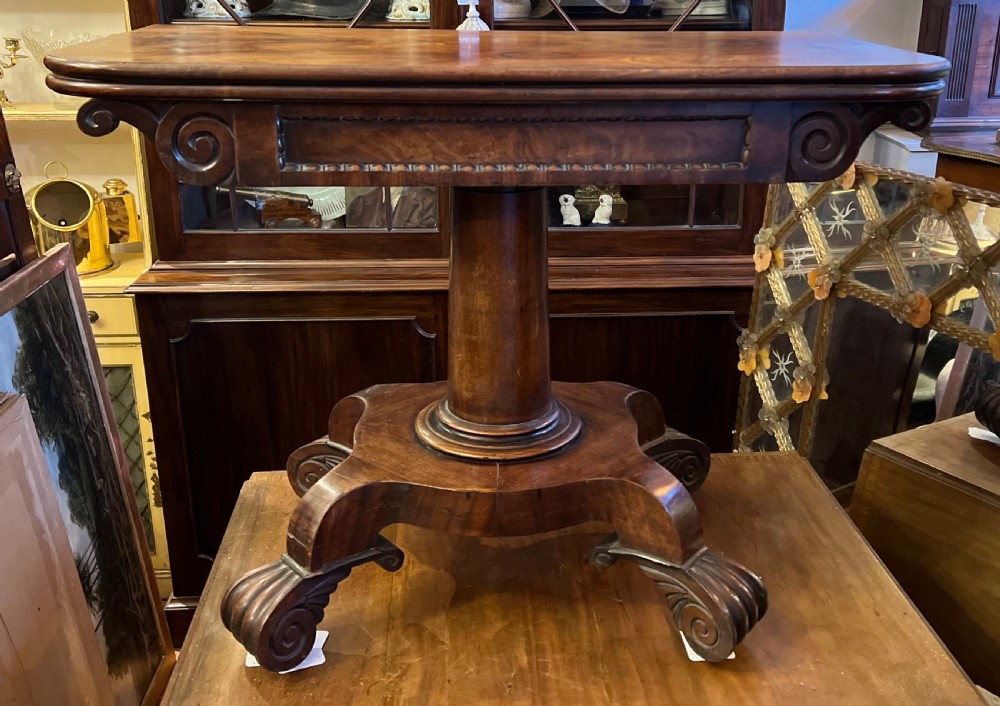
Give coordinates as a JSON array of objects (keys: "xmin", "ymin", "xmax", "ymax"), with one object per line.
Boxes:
[{"xmin": 25, "ymin": 162, "xmax": 114, "ymax": 276}]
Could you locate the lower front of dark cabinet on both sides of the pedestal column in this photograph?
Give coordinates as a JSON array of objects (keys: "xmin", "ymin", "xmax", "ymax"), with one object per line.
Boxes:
[{"xmin": 136, "ymin": 280, "xmax": 753, "ymax": 604}]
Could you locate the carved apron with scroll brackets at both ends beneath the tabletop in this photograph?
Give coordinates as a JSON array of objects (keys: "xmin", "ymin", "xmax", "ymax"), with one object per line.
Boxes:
[{"xmin": 72, "ymin": 94, "xmax": 940, "ymax": 187}]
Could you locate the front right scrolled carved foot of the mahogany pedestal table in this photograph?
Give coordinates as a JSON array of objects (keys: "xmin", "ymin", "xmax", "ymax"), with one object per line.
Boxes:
[{"xmin": 590, "ymin": 535, "xmax": 767, "ymax": 662}]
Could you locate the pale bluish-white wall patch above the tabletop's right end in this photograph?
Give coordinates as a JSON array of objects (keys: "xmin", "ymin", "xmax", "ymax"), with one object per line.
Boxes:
[{"xmin": 785, "ymin": 0, "xmax": 922, "ymax": 49}]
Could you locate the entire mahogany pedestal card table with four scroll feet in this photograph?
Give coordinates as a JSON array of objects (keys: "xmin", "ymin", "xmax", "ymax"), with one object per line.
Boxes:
[{"xmin": 46, "ymin": 25, "xmax": 948, "ymax": 670}]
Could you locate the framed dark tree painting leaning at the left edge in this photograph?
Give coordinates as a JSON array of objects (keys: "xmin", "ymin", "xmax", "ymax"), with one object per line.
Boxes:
[{"xmin": 0, "ymin": 246, "xmax": 174, "ymax": 706}]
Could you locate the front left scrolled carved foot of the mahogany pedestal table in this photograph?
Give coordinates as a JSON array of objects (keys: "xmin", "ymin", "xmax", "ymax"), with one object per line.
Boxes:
[{"xmin": 222, "ymin": 535, "xmax": 403, "ymax": 672}]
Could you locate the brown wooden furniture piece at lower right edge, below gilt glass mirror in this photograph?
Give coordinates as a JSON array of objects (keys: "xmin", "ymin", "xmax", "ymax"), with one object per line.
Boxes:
[{"xmin": 851, "ymin": 414, "xmax": 1000, "ymax": 693}]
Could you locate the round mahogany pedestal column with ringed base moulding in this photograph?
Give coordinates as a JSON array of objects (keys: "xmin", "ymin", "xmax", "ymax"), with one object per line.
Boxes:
[{"xmin": 417, "ymin": 188, "xmax": 580, "ymax": 461}]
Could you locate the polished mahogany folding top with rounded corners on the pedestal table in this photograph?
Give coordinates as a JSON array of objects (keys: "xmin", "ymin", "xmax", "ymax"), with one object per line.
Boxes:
[{"xmin": 45, "ymin": 24, "xmax": 948, "ymax": 99}]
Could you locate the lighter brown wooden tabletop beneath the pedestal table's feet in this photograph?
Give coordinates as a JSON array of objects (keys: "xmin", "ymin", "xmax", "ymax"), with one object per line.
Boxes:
[{"xmin": 164, "ymin": 454, "xmax": 982, "ymax": 706}]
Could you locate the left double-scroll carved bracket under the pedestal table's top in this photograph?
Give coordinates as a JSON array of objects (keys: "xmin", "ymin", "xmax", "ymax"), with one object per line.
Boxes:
[{"xmin": 77, "ymin": 99, "xmax": 236, "ymax": 186}]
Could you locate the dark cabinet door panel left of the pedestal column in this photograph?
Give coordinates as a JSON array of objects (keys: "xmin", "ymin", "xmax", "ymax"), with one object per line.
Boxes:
[{"xmin": 137, "ymin": 295, "xmax": 441, "ymax": 595}]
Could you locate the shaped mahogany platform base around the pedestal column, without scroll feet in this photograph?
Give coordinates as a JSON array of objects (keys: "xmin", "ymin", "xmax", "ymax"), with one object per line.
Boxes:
[{"xmin": 287, "ymin": 383, "xmax": 703, "ymax": 570}]
